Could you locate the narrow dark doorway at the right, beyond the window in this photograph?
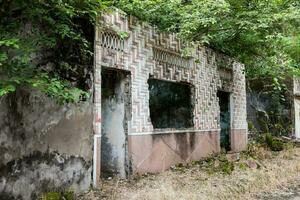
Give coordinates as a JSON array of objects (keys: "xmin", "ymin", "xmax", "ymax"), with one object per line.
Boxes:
[{"xmin": 218, "ymin": 91, "xmax": 231, "ymax": 151}]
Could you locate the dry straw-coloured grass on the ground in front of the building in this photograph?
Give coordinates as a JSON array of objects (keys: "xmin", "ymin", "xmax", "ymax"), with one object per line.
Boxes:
[{"xmin": 82, "ymin": 147, "xmax": 300, "ymax": 200}]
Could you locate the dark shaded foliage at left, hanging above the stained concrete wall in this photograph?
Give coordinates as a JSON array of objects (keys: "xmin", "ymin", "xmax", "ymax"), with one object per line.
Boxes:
[{"xmin": 0, "ymin": 0, "xmax": 111, "ymax": 102}]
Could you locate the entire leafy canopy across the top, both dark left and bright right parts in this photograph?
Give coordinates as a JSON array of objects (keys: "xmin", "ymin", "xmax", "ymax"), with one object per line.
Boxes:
[{"xmin": 0, "ymin": 0, "xmax": 300, "ymax": 102}]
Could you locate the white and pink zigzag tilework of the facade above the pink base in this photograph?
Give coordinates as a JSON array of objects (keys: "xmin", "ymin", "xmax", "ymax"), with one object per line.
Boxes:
[{"xmin": 94, "ymin": 12, "xmax": 247, "ymax": 135}]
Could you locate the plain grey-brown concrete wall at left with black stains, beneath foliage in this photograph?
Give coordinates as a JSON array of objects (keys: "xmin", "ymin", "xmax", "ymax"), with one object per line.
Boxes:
[{"xmin": 0, "ymin": 89, "xmax": 93, "ymax": 200}]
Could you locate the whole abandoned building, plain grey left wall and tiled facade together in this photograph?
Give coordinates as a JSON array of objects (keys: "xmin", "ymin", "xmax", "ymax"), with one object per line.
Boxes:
[{"xmin": 0, "ymin": 11, "xmax": 247, "ymax": 200}]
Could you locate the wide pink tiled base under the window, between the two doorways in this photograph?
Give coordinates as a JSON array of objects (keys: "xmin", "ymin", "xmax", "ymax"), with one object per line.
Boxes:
[{"xmin": 128, "ymin": 131, "xmax": 220, "ymax": 173}]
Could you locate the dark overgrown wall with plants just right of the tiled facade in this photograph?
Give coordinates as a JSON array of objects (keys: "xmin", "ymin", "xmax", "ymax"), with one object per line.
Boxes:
[{"xmin": 247, "ymin": 77, "xmax": 294, "ymax": 137}]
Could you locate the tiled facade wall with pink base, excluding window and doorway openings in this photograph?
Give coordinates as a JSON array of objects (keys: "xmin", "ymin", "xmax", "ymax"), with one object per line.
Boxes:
[{"xmin": 94, "ymin": 9, "xmax": 247, "ymax": 181}]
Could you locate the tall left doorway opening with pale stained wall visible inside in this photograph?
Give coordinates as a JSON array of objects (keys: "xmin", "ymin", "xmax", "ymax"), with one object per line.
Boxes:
[{"xmin": 101, "ymin": 68, "xmax": 131, "ymax": 178}]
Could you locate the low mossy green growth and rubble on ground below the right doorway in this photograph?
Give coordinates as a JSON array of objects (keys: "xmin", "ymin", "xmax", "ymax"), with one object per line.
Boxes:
[{"xmin": 171, "ymin": 133, "xmax": 295, "ymax": 175}]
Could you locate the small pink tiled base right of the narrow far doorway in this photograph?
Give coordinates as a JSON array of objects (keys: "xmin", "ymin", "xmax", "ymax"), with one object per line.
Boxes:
[{"xmin": 230, "ymin": 129, "xmax": 248, "ymax": 152}]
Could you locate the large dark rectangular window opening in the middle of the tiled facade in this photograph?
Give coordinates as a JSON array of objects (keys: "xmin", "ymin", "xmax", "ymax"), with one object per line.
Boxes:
[{"xmin": 148, "ymin": 79, "xmax": 194, "ymax": 129}]
